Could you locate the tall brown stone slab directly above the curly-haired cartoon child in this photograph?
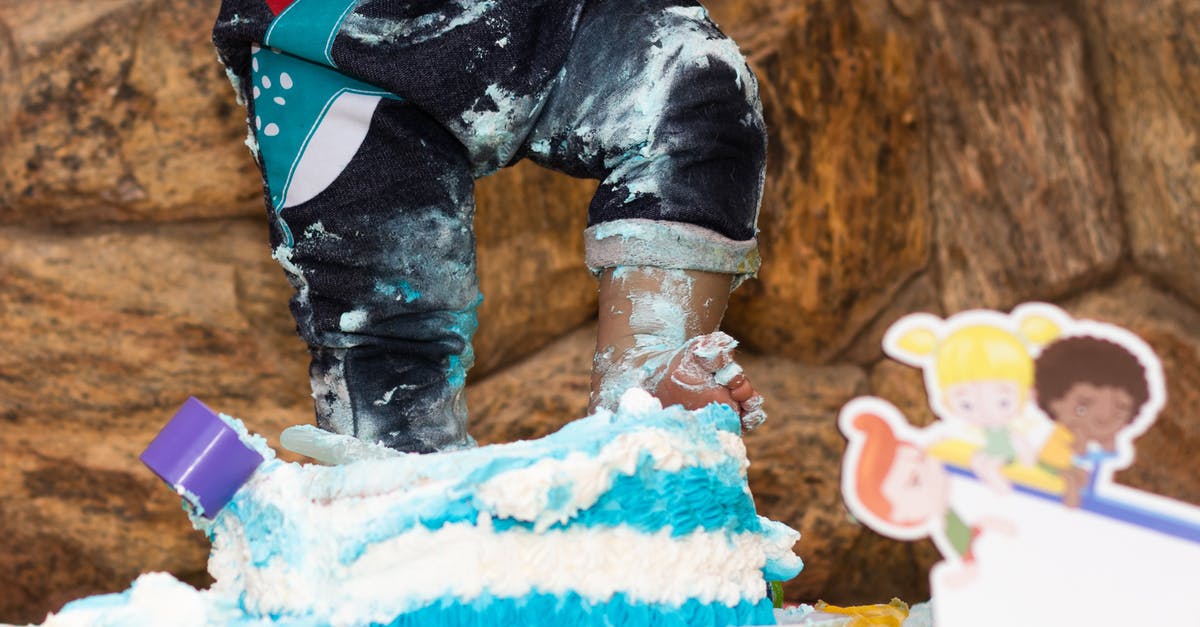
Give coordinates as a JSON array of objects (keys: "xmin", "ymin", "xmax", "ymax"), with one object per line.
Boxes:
[{"xmin": 923, "ymin": 1, "xmax": 1123, "ymax": 312}]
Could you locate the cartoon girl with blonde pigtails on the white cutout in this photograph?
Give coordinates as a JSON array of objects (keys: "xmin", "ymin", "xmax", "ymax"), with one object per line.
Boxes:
[{"xmin": 884, "ymin": 305, "xmax": 1062, "ymax": 491}]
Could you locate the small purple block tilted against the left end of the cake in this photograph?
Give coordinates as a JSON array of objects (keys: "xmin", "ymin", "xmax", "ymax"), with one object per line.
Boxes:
[{"xmin": 142, "ymin": 398, "xmax": 263, "ymax": 519}]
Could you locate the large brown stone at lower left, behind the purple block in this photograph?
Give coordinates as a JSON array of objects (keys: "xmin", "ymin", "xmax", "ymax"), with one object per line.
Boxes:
[{"xmin": 0, "ymin": 220, "xmax": 311, "ymax": 622}]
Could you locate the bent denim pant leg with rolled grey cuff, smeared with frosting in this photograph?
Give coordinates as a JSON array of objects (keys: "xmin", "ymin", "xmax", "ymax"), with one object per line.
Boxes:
[{"xmin": 521, "ymin": 0, "xmax": 767, "ymax": 282}]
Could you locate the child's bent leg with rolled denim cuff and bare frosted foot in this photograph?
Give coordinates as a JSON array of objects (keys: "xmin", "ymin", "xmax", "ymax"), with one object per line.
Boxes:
[{"xmin": 524, "ymin": 0, "xmax": 766, "ymax": 425}]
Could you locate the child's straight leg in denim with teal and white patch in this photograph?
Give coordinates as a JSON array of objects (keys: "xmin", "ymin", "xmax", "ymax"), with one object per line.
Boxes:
[{"xmin": 220, "ymin": 48, "xmax": 480, "ymax": 452}]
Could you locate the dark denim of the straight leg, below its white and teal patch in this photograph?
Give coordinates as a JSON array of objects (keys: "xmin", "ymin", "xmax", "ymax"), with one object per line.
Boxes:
[{"xmin": 263, "ymin": 88, "xmax": 481, "ymax": 452}]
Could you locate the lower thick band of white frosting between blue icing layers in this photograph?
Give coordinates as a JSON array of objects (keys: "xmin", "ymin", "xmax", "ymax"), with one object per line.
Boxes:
[{"xmin": 214, "ymin": 516, "xmax": 798, "ymax": 625}]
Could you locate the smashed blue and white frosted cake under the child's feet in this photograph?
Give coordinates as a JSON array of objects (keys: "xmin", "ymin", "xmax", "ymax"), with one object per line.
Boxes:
[{"xmin": 47, "ymin": 393, "xmax": 802, "ymax": 626}]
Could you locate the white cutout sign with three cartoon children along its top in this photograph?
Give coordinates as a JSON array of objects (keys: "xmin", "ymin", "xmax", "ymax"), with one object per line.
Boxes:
[{"xmin": 839, "ymin": 303, "xmax": 1200, "ymax": 627}]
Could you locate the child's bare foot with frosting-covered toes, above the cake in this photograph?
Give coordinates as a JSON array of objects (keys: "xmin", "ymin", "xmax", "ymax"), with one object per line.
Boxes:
[{"xmin": 649, "ymin": 332, "xmax": 767, "ymax": 430}]
